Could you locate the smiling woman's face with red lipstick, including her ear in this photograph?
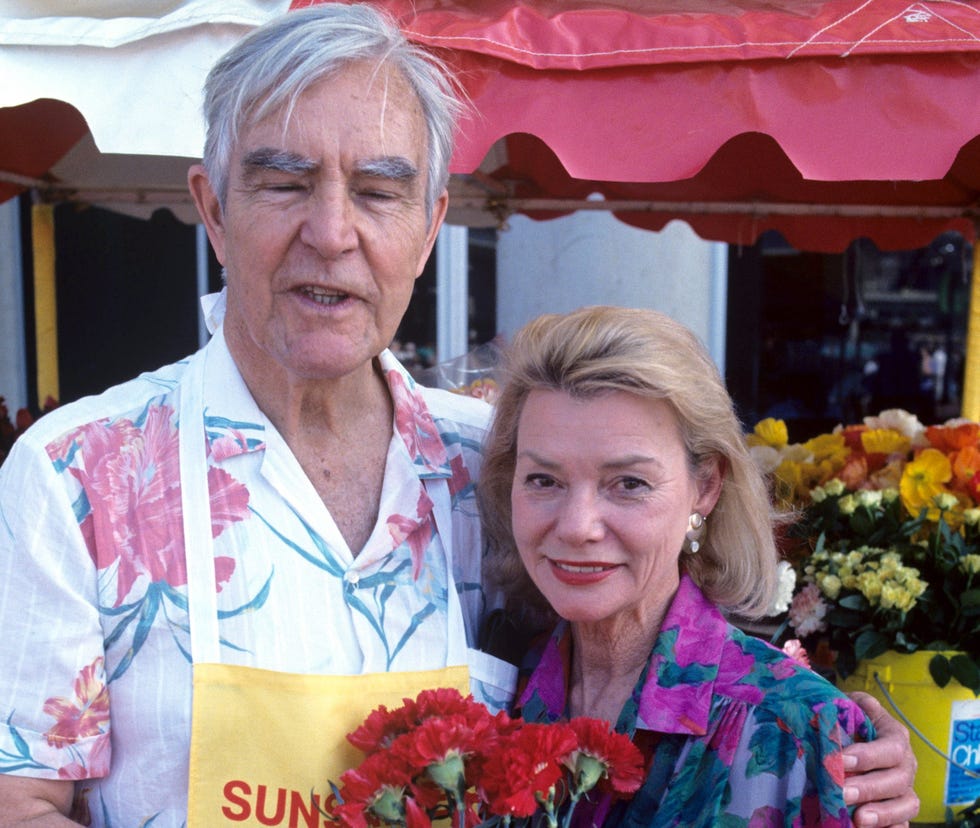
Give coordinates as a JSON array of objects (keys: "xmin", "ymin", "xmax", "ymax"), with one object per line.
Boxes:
[{"xmin": 511, "ymin": 390, "xmax": 717, "ymax": 624}]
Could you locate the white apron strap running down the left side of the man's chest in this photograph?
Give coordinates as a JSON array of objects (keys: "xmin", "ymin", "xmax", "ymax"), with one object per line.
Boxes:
[{"xmin": 177, "ymin": 351, "xmax": 221, "ymax": 664}]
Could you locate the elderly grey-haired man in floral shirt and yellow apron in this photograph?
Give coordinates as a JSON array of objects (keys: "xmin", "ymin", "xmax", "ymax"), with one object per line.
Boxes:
[{"xmin": 0, "ymin": 5, "xmax": 915, "ymax": 828}]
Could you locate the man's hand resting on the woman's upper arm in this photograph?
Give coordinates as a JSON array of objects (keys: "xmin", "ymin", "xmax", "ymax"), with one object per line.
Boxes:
[{"xmin": 844, "ymin": 693, "xmax": 919, "ymax": 828}]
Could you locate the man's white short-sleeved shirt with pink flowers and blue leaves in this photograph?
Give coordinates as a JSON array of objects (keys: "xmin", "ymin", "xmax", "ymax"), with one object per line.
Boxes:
[{"xmin": 0, "ymin": 331, "xmax": 489, "ymax": 828}]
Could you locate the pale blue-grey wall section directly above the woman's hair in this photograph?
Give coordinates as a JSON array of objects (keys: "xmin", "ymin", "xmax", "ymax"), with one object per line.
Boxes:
[{"xmin": 497, "ymin": 211, "xmax": 727, "ymax": 369}]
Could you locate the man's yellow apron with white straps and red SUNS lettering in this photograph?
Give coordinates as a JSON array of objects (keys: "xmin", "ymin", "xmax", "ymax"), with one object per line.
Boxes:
[{"xmin": 179, "ymin": 352, "xmax": 516, "ymax": 828}]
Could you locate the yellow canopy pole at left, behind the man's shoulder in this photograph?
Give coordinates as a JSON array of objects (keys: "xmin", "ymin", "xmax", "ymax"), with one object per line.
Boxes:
[{"xmin": 31, "ymin": 204, "xmax": 61, "ymax": 409}]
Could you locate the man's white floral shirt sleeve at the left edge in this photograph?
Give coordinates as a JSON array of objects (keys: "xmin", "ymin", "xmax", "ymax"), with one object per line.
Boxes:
[{"xmin": 0, "ymin": 433, "xmax": 110, "ymax": 779}]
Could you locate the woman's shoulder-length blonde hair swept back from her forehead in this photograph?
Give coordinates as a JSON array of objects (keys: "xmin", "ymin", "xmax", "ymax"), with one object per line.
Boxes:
[{"xmin": 478, "ymin": 307, "xmax": 777, "ymax": 617}]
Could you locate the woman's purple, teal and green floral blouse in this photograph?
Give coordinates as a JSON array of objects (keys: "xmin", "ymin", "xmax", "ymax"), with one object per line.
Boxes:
[{"xmin": 519, "ymin": 576, "xmax": 873, "ymax": 828}]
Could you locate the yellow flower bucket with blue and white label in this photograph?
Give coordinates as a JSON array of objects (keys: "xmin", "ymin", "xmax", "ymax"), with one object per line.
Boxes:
[{"xmin": 841, "ymin": 651, "xmax": 980, "ymax": 823}]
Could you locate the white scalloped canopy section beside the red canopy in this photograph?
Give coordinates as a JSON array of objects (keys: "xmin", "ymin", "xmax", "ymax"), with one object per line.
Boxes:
[{"xmin": 0, "ymin": 0, "xmax": 289, "ymax": 157}]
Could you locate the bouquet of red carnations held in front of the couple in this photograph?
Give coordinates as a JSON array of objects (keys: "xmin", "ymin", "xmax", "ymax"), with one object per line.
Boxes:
[{"xmin": 326, "ymin": 689, "xmax": 643, "ymax": 828}]
